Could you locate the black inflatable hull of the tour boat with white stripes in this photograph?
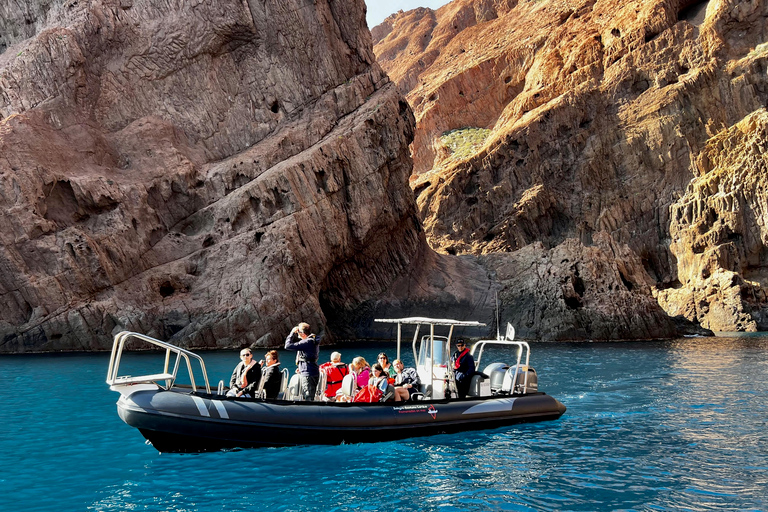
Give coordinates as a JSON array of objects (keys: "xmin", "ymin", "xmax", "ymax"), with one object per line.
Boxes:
[{"xmin": 117, "ymin": 390, "xmax": 565, "ymax": 452}]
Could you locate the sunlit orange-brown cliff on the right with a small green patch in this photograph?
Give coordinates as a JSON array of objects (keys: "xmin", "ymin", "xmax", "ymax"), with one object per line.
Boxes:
[{"xmin": 372, "ymin": 0, "xmax": 768, "ymax": 338}]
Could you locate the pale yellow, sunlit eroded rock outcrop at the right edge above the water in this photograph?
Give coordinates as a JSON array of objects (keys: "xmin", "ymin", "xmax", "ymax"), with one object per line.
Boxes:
[{"xmin": 659, "ymin": 109, "xmax": 768, "ymax": 331}]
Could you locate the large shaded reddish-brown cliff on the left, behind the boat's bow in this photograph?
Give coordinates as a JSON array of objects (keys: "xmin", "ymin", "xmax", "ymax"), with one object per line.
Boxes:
[{"xmin": 0, "ymin": 0, "xmax": 489, "ymax": 352}]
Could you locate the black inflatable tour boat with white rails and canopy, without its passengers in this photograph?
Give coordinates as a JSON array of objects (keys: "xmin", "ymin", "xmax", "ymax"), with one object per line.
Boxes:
[{"xmin": 107, "ymin": 317, "xmax": 566, "ymax": 452}]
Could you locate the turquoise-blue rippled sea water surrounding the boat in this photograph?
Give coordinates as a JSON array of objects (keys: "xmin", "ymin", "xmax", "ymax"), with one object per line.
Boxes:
[{"xmin": 0, "ymin": 337, "xmax": 768, "ymax": 511}]
